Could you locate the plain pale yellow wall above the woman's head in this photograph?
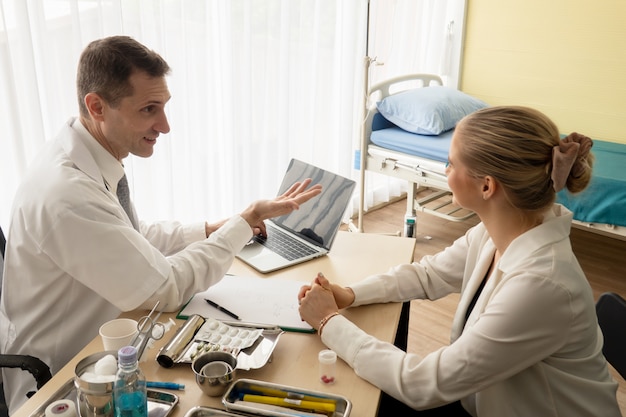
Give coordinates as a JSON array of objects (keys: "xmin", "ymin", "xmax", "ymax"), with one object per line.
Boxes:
[{"xmin": 461, "ymin": 0, "xmax": 626, "ymax": 143}]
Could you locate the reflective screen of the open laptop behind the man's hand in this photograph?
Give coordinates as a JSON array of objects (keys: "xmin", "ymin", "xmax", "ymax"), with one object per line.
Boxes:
[{"xmin": 272, "ymin": 159, "xmax": 356, "ymax": 249}]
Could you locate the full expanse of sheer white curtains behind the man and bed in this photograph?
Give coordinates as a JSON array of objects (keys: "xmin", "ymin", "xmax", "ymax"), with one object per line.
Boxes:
[{"xmin": 0, "ymin": 0, "xmax": 464, "ymax": 228}]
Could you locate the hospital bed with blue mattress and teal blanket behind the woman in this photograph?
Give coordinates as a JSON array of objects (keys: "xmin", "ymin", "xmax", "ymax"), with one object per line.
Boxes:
[{"xmin": 358, "ymin": 74, "xmax": 626, "ymax": 240}]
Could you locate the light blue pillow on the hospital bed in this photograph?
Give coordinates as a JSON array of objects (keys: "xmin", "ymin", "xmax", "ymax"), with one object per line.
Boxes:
[{"xmin": 376, "ymin": 86, "xmax": 488, "ymax": 135}]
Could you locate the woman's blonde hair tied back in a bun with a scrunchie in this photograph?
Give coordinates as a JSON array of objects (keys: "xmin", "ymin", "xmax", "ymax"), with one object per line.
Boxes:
[{"xmin": 455, "ymin": 106, "xmax": 593, "ymax": 211}]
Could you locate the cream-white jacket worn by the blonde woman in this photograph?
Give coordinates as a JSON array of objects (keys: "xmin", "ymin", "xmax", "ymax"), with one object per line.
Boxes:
[{"xmin": 322, "ymin": 205, "xmax": 621, "ymax": 417}]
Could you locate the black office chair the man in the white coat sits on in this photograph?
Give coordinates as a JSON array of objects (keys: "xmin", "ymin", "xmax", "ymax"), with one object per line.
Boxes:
[{"xmin": 0, "ymin": 227, "xmax": 52, "ymax": 417}]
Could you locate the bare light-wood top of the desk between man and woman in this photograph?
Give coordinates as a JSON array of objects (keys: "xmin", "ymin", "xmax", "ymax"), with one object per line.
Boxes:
[{"xmin": 14, "ymin": 232, "xmax": 415, "ymax": 417}]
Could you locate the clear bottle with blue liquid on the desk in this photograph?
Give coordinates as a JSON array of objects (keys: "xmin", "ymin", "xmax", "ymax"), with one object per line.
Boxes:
[{"xmin": 113, "ymin": 346, "xmax": 148, "ymax": 417}]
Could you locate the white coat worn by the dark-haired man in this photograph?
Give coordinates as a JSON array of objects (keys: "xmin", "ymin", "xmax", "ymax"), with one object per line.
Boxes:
[{"xmin": 0, "ymin": 119, "xmax": 252, "ymax": 414}]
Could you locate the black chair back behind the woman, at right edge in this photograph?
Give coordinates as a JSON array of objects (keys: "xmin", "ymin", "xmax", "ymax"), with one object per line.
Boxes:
[{"xmin": 596, "ymin": 292, "xmax": 626, "ymax": 379}]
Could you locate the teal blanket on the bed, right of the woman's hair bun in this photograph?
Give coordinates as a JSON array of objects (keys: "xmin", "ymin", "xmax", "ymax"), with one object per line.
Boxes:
[{"xmin": 557, "ymin": 140, "xmax": 626, "ymax": 226}]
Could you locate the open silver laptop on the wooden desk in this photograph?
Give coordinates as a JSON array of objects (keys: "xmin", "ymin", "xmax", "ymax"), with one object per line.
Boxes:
[{"xmin": 237, "ymin": 159, "xmax": 356, "ymax": 273}]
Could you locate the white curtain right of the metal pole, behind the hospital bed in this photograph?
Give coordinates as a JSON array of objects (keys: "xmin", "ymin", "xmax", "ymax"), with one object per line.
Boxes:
[{"xmin": 357, "ymin": 0, "xmax": 466, "ymax": 213}]
